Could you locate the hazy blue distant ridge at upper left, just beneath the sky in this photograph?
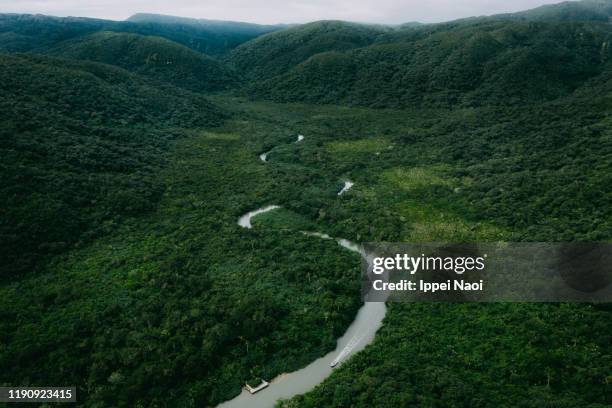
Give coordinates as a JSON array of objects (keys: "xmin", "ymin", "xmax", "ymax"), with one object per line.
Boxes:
[{"xmin": 0, "ymin": 14, "xmax": 281, "ymax": 56}]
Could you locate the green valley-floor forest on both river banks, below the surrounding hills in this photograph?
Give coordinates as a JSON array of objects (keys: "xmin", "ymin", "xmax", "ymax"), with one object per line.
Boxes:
[{"xmin": 0, "ymin": 85, "xmax": 612, "ymax": 406}]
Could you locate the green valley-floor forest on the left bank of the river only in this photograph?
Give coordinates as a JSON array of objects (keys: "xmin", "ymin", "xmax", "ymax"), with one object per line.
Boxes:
[{"xmin": 0, "ymin": 121, "xmax": 360, "ymax": 406}]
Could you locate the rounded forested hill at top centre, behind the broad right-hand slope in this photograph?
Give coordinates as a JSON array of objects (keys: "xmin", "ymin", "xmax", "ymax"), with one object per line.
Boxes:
[{"xmin": 227, "ymin": 21, "xmax": 391, "ymax": 79}]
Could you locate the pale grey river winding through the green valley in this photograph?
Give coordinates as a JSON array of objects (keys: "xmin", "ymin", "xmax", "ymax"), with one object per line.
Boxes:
[{"xmin": 218, "ymin": 135, "xmax": 386, "ymax": 408}]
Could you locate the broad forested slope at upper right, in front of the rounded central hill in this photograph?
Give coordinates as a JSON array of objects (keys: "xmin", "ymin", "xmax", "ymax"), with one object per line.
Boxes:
[{"xmin": 244, "ymin": 20, "xmax": 612, "ymax": 107}]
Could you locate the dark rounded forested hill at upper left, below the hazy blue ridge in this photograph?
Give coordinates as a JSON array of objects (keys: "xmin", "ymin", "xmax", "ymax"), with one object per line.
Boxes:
[{"xmin": 49, "ymin": 31, "xmax": 237, "ymax": 91}]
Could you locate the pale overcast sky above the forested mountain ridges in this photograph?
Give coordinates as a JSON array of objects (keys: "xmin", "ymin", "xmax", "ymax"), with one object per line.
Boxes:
[{"xmin": 0, "ymin": 0, "xmax": 561, "ymax": 24}]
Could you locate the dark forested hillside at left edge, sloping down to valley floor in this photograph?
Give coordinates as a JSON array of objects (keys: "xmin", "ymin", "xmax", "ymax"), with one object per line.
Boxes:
[{"xmin": 0, "ymin": 54, "xmax": 227, "ymax": 275}]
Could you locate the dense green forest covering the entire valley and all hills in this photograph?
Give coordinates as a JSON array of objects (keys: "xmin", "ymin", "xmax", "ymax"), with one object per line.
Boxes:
[{"xmin": 0, "ymin": 0, "xmax": 612, "ymax": 408}]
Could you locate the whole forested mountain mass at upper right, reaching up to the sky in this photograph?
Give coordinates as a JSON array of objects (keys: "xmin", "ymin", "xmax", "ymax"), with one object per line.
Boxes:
[{"xmin": 237, "ymin": 1, "xmax": 612, "ymax": 107}]
